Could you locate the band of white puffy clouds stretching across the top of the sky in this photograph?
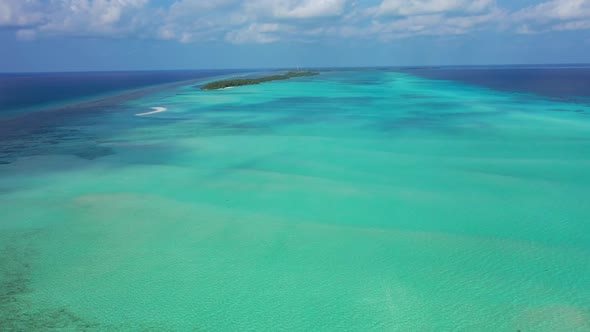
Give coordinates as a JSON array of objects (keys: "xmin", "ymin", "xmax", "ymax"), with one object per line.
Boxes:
[{"xmin": 0, "ymin": 0, "xmax": 590, "ymax": 44}]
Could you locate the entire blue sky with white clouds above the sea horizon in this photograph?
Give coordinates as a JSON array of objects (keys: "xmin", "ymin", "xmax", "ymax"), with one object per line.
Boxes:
[{"xmin": 0, "ymin": 0, "xmax": 590, "ymax": 72}]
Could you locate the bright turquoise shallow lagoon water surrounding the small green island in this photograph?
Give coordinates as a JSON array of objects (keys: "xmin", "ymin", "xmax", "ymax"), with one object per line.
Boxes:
[{"xmin": 0, "ymin": 71, "xmax": 590, "ymax": 331}]
